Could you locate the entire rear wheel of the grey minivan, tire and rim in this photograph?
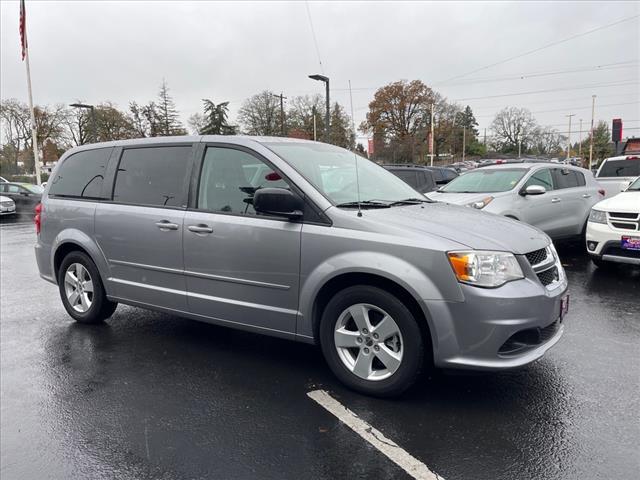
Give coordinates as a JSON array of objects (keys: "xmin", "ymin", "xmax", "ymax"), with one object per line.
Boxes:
[{"xmin": 58, "ymin": 251, "xmax": 118, "ymax": 323}]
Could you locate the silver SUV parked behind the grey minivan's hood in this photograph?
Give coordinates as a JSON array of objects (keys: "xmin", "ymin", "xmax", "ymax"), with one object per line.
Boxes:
[{"xmin": 427, "ymin": 163, "xmax": 604, "ymax": 240}]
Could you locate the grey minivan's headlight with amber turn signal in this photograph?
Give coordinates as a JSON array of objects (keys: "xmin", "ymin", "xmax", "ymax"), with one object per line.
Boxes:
[{"xmin": 447, "ymin": 251, "xmax": 524, "ymax": 287}]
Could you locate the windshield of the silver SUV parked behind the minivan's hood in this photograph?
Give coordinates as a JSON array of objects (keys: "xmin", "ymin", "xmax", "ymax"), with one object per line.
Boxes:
[{"xmin": 439, "ymin": 168, "xmax": 527, "ymax": 193}]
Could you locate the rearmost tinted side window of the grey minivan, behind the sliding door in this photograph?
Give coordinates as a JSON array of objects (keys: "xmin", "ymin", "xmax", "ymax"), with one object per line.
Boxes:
[{"xmin": 49, "ymin": 148, "xmax": 112, "ymax": 198}]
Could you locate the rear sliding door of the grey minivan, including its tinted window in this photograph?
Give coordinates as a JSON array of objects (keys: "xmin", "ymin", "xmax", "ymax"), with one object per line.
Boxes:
[{"xmin": 95, "ymin": 144, "xmax": 192, "ymax": 311}]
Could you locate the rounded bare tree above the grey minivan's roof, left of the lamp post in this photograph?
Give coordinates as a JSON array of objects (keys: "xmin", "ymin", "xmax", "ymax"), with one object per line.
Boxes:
[{"xmin": 238, "ymin": 90, "xmax": 280, "ymax": 136}]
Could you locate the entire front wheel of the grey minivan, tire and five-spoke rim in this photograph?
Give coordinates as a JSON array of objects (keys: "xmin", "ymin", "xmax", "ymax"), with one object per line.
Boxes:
[{"xmin": 319, "ymin": 285, "xmax": 424, "ymax": 397}]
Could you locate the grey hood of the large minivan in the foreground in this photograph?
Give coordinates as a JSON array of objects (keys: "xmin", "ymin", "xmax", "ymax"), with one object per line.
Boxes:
[{"xmin": 350, "ymin": 203, "xmax": 551, "ymax": 254}]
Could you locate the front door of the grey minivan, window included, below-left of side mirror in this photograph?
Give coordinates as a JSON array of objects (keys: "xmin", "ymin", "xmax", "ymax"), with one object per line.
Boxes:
[{"xmin": 184, "ymin": 146, "xmax": 301, "ymax": 333}]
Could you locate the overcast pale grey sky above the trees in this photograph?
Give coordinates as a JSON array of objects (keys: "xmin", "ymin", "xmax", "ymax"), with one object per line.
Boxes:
[{"xmin": 0, "ymin": 0, "xmax": 640, "ymax": 140}]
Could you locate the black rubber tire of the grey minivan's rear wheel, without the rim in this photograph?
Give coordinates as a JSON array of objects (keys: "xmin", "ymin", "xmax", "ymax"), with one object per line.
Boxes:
[{"xmin": 58, "ymin": 251, "xmax": 118, "ymax": 323}]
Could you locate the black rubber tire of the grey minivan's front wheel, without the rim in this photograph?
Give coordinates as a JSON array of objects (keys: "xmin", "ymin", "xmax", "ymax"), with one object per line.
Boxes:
[{"xmin": 319, "ymin": 285, "xmax": 425, "ymax": 397}]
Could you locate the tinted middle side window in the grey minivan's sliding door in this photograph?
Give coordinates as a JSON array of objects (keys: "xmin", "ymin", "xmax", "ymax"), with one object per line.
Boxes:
[{"xmin": 113, "ymin": 145, "xmax": 191, "ymax": 207}]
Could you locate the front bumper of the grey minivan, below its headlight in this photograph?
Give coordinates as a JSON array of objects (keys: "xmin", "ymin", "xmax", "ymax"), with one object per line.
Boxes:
[{"xmin": 425, "ymin": 263, "xmax": 567, "ymax": 370}]
